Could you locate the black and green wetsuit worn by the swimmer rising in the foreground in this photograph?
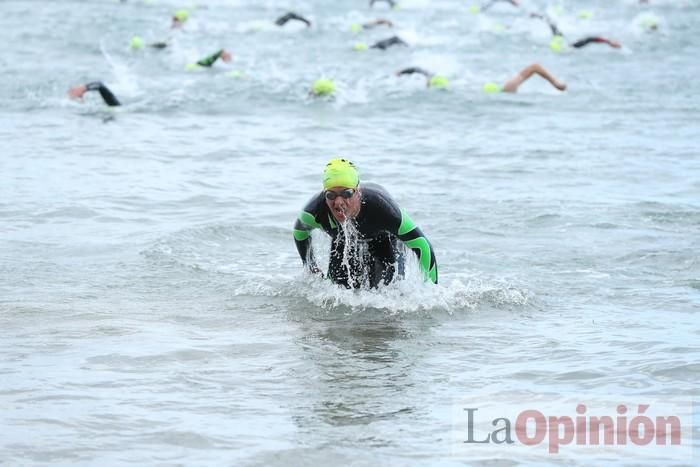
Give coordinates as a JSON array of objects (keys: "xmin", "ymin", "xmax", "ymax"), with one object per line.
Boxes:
[{"xmin": 294, "ymin": 183, "xmax": 438, "ymax": 288}]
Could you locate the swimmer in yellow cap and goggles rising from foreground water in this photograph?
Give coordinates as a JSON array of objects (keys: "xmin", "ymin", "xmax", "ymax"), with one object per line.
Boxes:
[{"xmin": 294, "ymin": 159, "xmax": 438, "ymax": 289}]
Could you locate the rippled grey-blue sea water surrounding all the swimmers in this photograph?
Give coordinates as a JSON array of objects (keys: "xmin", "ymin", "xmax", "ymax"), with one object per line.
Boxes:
[{"xmin": 0, "ymin": 0, "xmax": 700, "ymax": 465}]
